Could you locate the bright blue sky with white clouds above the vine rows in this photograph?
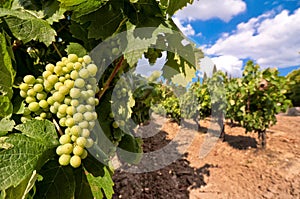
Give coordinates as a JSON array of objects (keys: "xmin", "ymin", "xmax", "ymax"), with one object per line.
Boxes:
[{"xmin": 173, "ymin": 0, "xmax": 300, "ymax": 76}]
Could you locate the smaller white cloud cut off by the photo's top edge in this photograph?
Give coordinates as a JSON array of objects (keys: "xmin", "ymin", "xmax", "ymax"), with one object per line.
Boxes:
[{"xmin": 175, "ymin": 0, "xmax": 246, "ymax": 22}]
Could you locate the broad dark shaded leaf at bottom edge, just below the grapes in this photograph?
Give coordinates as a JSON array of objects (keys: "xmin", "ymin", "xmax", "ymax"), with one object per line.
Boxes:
[{"xmin": 34, "ymin": 159, "xmax": 76, "ymax": 199}]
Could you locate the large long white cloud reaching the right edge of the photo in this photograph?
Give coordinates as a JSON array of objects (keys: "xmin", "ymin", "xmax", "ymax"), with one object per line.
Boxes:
[{"xmin": 204, "ymin": 8, "xmax": 300, "ymax": 67}]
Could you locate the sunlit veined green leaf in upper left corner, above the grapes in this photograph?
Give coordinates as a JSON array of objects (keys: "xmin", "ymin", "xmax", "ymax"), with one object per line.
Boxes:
[{"xmin": 0, "ymin": 8, "xmax": 56, "ymax": 46}]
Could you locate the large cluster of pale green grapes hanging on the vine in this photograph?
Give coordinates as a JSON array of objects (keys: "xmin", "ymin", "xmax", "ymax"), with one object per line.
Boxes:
[{"xmin": 20, "ymin": 54, "xmax": 99, "ymax": 168}]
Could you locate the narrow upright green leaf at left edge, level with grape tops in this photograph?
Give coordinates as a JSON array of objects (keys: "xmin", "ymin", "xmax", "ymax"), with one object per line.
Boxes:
[{"xmin": 0, "ymin": 31, "xmax": 16, "ymax": 99}]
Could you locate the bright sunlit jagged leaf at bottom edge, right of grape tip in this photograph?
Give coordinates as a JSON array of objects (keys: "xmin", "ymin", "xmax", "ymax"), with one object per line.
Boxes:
[{"xmin": 87, "ymin": 167, "xmax": 114, "ymax": 199}]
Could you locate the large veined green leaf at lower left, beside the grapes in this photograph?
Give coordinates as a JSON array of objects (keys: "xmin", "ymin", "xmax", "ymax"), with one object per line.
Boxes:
[{"xmin": 0, "ymin": 120, "xmax": 58, "ymax": 190}]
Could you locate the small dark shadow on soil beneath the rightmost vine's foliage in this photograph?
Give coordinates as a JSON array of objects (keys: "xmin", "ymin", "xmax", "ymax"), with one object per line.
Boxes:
[{"xmin": 224, "ymin": 134, "xmax": 258, "ymax": 150}]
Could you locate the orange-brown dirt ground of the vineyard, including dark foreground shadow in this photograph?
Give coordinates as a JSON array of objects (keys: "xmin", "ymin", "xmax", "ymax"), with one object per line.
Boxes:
[{"xmin": 113, "ymin": 116, "xmax": 300, "ymax": 199}]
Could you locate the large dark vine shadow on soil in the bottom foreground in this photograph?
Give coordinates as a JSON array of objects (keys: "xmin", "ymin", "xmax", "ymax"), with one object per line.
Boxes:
[{"xmin": 113, "ymin": 131, "xmax": 214, "ymax": 199}]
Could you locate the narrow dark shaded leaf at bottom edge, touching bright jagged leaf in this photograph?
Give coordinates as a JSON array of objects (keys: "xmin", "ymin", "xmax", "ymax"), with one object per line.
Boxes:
[{"xmin": 74, "ymin": 167, "xmax": 94, "ymax": 199}]
